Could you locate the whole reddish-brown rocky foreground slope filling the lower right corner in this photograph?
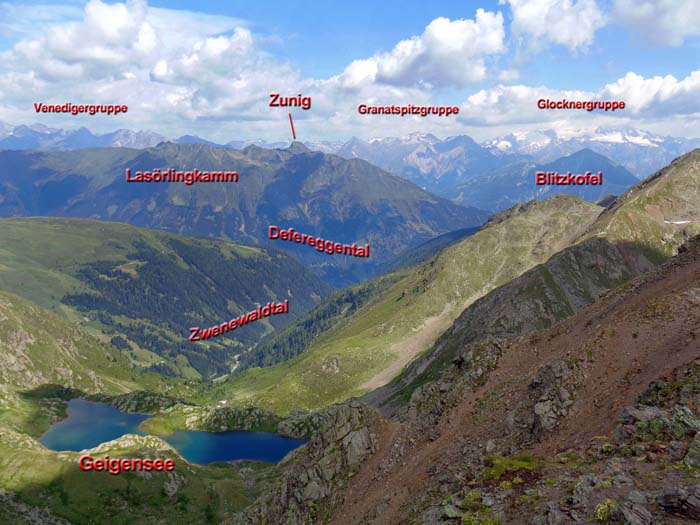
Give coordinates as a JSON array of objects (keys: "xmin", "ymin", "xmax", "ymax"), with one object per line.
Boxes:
[{"xmin": 330, "ymin": 234, "xmax": 700, "ymax": 525}]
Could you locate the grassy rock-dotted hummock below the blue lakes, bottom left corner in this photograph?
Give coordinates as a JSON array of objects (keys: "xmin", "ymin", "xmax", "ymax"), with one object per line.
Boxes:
[{"xmin": 0, "ymin": 427, "xmax": 262, "ymax": 525}]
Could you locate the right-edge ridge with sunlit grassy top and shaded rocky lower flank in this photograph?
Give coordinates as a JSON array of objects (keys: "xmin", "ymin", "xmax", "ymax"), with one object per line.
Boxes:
[{"xmin": 371, "ymin": 150, "xmax": 700, "ymax": 414}]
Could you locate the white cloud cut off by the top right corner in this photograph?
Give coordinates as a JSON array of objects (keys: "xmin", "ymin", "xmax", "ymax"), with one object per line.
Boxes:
[{"xmin": 614, "ymin": 0, "xmax": 700, "ymax": 46}]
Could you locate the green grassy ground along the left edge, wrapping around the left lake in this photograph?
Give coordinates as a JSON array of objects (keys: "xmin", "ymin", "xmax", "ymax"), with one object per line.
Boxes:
[{"xmin": 0, "ymin": 292, "xmax": 262, "ymax": 524}]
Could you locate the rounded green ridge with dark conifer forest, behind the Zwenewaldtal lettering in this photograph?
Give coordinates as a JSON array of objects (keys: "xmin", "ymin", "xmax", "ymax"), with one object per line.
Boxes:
[{"xmin": 0, "ymin": 218, "xmax": 331, "ymax": 378}]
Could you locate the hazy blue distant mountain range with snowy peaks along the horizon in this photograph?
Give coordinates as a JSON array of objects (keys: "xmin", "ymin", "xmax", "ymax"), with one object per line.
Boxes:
[{"xmin": 0, "ymin": 123, "xmax": 700, "ymax": 181}]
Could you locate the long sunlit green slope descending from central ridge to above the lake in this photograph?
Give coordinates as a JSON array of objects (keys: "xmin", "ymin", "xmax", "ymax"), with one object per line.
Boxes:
[{"xmin": 213, "ymin": 196, "xmax": 600, "ymax": 413}]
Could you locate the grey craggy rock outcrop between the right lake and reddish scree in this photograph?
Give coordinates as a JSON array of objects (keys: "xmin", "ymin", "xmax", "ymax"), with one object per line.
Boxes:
[{"xmin": 238, "ymin": 400, "xmax": 378, "ymax": 525}]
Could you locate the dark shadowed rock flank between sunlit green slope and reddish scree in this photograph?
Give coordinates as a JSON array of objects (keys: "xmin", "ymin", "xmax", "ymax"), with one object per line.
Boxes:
[{"xmin": 362, "ymin": 238, "xmax": 665, "ymax": 415}]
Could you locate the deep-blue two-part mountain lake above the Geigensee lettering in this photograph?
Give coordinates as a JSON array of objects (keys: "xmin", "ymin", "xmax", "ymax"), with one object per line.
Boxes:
[{"xmin": 39, "ymin": 399, "xmax": 306, "ymax": 465}]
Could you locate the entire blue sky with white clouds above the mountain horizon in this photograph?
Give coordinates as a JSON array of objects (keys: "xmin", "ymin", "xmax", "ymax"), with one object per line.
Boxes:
[{"xmin": 0, "ymin": 0, "xmax": 700, "ymax": 142}]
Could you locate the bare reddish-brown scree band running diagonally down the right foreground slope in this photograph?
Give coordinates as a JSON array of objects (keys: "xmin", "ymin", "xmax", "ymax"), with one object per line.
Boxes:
[{"xmin": 332, "ymin": 243, "xmax": 700, "ymax": 525}]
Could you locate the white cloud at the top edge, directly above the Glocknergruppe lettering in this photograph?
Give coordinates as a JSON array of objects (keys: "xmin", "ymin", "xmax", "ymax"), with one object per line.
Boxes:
[{"xmin": 507, "ymin": 0, "xmax": 607, "ymax": 51}]
